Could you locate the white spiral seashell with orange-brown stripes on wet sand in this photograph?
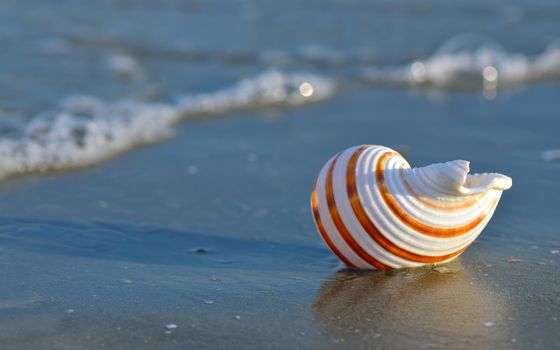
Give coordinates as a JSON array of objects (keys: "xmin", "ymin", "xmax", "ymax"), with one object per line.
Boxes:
[{"xmin": 311, "ymin": 145, "xmax": 511, "ymax": 269}]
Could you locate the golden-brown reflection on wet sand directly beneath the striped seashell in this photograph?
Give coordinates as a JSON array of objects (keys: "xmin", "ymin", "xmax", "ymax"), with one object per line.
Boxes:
[{"xmin": 313, "ymin": 262, "xmax": 512, "ymax": 349}]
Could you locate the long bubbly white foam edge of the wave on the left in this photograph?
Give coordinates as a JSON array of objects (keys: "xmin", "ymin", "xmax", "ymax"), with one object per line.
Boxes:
[{"xmin": 0, "ymin": 71, "xmax": 336, "ymax": 179}]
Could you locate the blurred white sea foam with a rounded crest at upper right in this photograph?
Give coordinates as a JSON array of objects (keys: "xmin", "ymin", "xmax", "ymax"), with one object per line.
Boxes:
[{"xmin": 361, "ymin": 35, "xmax": 560, "ymax": 89}]
